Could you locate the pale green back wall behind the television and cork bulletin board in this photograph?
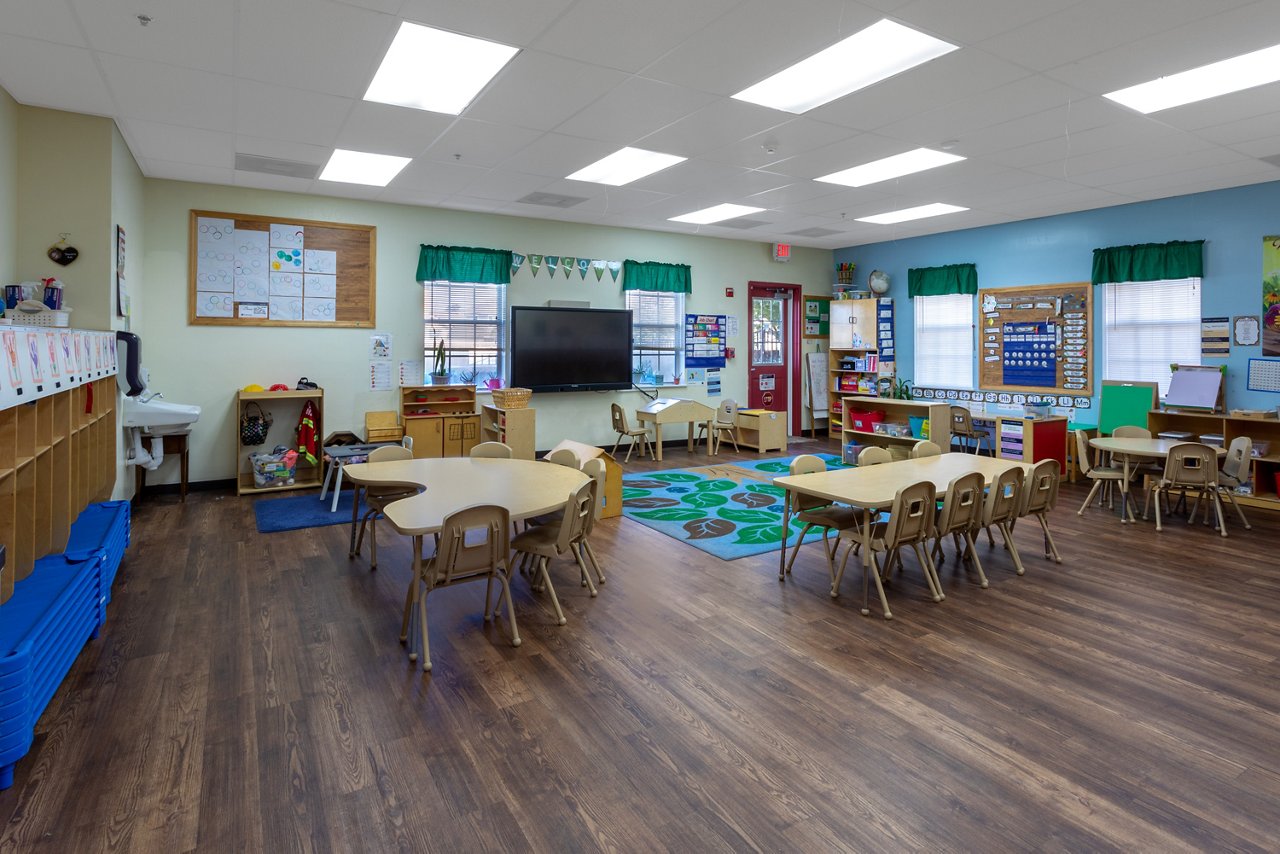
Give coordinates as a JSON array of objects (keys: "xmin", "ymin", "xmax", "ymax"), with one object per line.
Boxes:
[{"xmin": 142, "ymin": 179, "xmax": 832, "ymax": 483}]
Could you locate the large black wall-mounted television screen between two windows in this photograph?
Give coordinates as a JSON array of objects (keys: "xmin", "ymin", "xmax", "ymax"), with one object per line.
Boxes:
[{"xmin": 511, "ymin": 306, "xmax": 631, "ymax": 392}]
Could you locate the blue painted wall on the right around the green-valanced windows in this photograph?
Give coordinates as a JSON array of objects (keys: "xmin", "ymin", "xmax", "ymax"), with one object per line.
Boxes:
[{"xmin": 835, "ymin": 182, "xmax": 1280, "ymax": 408}]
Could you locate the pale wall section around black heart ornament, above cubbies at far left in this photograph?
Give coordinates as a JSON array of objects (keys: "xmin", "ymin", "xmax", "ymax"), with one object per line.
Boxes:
[{"xmin": 17, "ymin": 106, "xmax": 115, "ymax": 329}]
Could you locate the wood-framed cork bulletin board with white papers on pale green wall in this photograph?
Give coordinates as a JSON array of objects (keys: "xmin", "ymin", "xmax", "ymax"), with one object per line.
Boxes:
[{"xmin": 187, "ymin": 210, "xmax": 378, "ymax": 328}]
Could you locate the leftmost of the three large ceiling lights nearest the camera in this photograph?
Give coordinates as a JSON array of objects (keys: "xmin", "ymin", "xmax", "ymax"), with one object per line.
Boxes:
[{"xmin": 365, "ymin": 20, "xmax": 520, "ymax": 115}]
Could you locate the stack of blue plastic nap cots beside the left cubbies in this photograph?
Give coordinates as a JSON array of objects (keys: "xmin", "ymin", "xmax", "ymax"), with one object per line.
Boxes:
[{"xmin": 0, "ymin": 501, "xmax": 129, "ymax": 790}]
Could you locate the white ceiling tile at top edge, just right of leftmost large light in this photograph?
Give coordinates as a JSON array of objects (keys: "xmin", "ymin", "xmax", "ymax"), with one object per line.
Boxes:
[{"xmin": 530, "ymin": 0, "xmax": 737, "ymax": 72}]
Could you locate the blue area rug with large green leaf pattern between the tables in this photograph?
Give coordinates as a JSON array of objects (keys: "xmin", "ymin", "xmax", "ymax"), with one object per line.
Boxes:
[{"xmin": 622, "ymin": 453, "xmax": 846, "ymax": 561}]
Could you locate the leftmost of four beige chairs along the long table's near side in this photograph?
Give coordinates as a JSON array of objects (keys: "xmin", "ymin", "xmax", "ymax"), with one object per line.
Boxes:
[{"xmin": 832, "ymin": 480, "xmax": 946, "ymax": 620}]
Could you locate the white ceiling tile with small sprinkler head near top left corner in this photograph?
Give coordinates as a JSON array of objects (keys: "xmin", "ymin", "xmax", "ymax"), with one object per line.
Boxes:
[{"xmin": 72, "ymin": 0, "xmax": 237, "ymax": 74}]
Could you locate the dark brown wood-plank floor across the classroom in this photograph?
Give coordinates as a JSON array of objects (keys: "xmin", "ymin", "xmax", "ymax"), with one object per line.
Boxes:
[{"xmin": 0, "ymin": 443, "xmax": 1280, "ymax": 854}]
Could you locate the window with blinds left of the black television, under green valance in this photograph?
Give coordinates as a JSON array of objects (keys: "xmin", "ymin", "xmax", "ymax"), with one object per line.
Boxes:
[{"xmin": 422, "ymin": 282, "xmax": 507, "ymax": 384}]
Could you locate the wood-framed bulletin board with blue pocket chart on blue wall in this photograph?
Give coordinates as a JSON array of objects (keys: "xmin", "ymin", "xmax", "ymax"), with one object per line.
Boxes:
[{"xmin": 978, "ymin": 282, "xmax": 1093, "ymax": 397}]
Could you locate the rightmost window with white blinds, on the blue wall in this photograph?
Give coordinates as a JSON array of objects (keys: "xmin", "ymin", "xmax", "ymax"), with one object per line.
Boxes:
[{"xmin": 1102, "ymin": 279, "xmax": 1201, "ymax": 397}]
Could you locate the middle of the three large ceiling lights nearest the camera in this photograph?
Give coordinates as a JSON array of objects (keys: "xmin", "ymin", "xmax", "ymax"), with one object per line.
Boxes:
[{"xmin": 733, "ymin": 19, "xmax": 959, "ymax": 113}]
